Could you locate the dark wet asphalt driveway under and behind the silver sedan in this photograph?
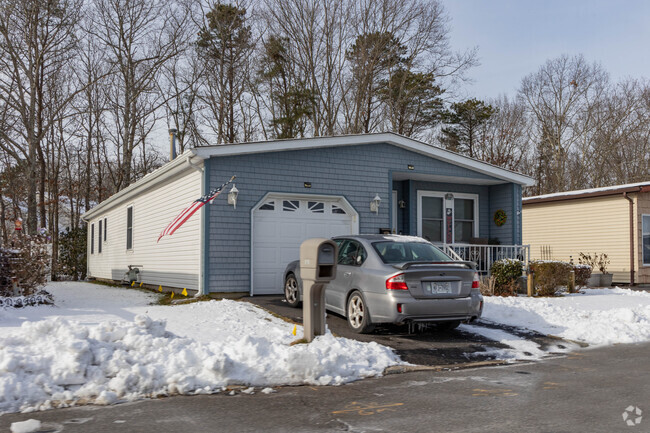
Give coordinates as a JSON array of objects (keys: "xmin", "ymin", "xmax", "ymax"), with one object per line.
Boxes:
[{"xmin": 242, "ymin": 295, "xmax": 569, "ymax": 368}]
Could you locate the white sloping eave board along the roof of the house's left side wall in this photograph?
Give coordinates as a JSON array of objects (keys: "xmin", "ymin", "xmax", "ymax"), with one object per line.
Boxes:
[{"xmin": 81, "ymin": 149, "xmax": 204, "ymax": 221}]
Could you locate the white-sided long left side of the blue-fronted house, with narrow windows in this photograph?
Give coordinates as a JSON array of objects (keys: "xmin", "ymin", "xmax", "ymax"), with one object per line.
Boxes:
[{"xmin": 83, "ymin": 152, "xmax": 203, "ymax": 291}]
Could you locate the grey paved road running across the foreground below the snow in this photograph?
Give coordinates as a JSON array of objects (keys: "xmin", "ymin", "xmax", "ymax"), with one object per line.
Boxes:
[{"xmin": 0, "ymin": 344, "xmax": 650, "ymax": 433}]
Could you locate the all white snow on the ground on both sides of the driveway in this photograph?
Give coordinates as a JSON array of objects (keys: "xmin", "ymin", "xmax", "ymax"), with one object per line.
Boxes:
[{"xmin": 0, "ymin": 282, "xmax": 650, "ymax": 413}]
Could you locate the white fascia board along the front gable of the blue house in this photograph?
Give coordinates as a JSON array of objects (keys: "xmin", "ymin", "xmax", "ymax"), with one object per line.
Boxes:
[{"xmin": 194, "ymin": 132, "xmax": 535, "ymax": 186}]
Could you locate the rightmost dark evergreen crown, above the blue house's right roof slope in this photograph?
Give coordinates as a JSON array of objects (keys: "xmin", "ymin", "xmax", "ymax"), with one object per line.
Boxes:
[{"xmin": 441, "ymin": 99, "xmax": 496, "ymax": 158}]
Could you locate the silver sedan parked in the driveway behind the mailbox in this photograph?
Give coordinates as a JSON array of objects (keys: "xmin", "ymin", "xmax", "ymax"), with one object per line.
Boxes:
[{"xmin": 284, "ymin": 235, "xmax": 483, "ymax": 333}]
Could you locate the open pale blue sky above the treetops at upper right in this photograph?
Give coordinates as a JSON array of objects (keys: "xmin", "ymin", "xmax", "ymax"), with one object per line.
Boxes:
[{"xmin": 443, "ymin": 0, "xmax": 650, "ymax": 99}]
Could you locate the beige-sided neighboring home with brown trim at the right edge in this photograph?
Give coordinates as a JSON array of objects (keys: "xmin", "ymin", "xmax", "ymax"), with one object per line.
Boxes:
[{"xmin": 523, "ymin": 181, "xmax": 650, "ymax": 284}]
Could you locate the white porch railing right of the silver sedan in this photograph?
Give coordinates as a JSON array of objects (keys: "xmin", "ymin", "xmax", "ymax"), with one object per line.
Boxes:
[{"xmin": 438, "ymin": 244, "xmax": 530, "ymax": 276}]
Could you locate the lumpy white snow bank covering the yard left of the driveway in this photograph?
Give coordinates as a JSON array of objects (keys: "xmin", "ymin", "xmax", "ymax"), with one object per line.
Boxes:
[{"xmin": 0, "ymin": 283, "xmax": 400, "ymax": 413}]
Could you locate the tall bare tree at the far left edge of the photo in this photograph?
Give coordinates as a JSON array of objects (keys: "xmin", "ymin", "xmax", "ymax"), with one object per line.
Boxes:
[{"xmin": 0, "ymin": 0, "xmax": 82, "ymax": 234}]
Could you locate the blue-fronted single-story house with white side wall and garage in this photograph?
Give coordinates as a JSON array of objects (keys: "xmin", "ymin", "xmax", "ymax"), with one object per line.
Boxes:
[{"xmin": 84, "ymin": 133, "xmax": 533, "ymax": 295}]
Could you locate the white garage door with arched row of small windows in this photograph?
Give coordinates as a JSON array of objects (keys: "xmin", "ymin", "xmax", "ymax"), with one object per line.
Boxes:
[{"xmin": 252, "ymin": 195, "xmax": 359, "ymax": 295}]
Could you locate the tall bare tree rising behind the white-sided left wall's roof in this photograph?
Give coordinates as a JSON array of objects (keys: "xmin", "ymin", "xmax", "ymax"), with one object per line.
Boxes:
[{"xmin": 90, "ymin": 0, "xmax": 186, "ymax": 190}]
